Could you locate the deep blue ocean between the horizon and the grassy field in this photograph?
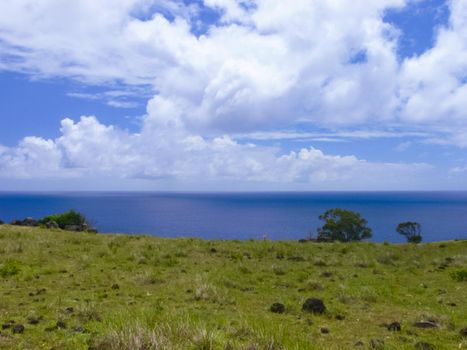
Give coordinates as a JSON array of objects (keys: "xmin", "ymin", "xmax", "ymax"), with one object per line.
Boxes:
[{"xmin": 0, "ymin": 192, "xmax": 467, "ymax": 242}]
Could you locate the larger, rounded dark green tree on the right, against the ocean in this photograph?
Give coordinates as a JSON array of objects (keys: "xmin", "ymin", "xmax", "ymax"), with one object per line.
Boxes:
[{"xmin": 318, "ymin": 208, "xmax": 372, "ymax": 242}]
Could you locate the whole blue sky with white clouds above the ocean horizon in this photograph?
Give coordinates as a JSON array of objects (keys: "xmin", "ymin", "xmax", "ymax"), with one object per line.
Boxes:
[{"xmin": 0, "ymin": 0, "xmax": 467, "ymax": 191}]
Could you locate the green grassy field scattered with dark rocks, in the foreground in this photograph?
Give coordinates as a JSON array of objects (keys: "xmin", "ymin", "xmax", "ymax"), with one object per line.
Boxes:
[{"xmin": 0, "ymin": 226, "xmax": 467, "ymax": 350}]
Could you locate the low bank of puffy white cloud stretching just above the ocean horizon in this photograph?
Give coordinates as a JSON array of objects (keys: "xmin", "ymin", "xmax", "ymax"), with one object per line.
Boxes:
[{"xmin": 0, "ymin": 115, "xmax": 429, "ymax": 189}]
